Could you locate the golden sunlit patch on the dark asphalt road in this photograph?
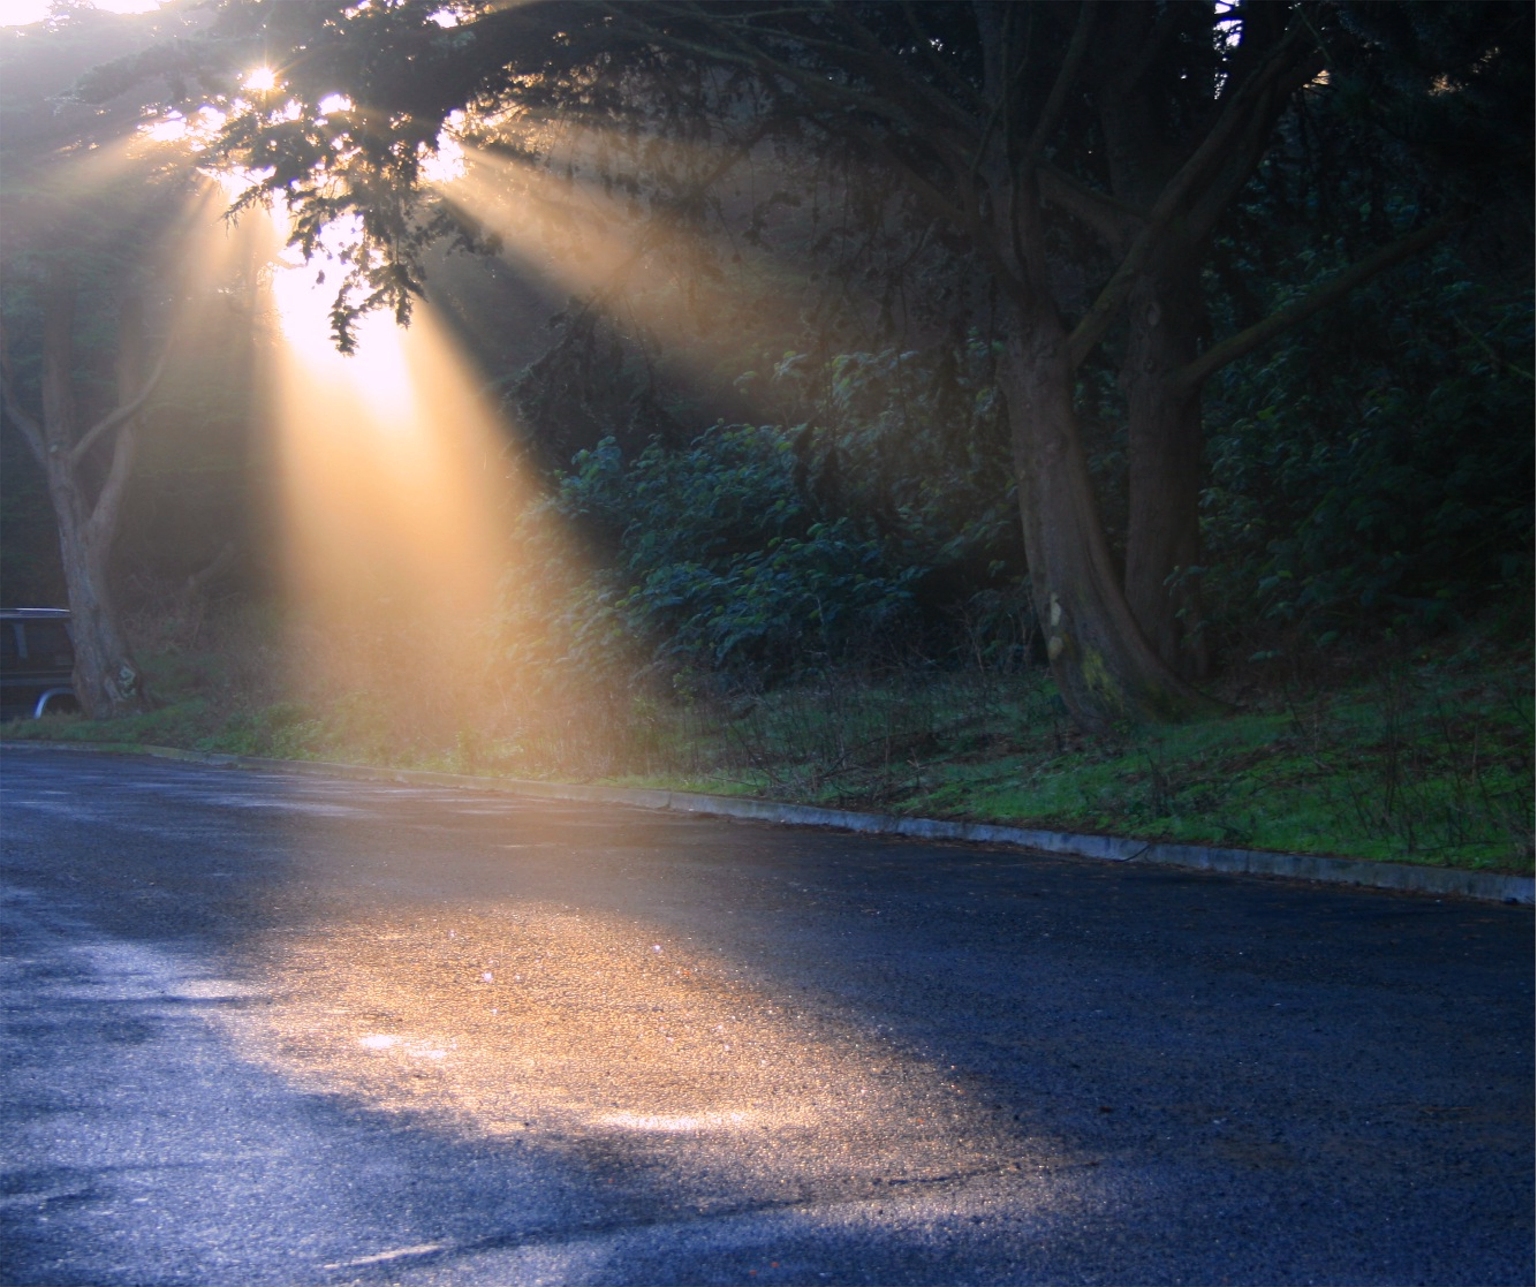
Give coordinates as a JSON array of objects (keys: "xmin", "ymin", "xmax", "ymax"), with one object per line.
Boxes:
[{"xmin": 227, "ymin": 903, "xmax": 1026, "ymax": 1196}]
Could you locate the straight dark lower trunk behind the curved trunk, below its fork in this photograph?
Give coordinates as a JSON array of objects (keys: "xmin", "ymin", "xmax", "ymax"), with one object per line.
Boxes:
[{"xmin": 1120, "ymin": 246, "xmax": 1210, "ymax": 679}]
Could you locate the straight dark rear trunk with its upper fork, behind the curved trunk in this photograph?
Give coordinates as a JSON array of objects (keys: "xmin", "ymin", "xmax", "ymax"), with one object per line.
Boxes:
[{"xmin": 1092, "ymin": 3, "xmax": 1313, "ymax": 679}]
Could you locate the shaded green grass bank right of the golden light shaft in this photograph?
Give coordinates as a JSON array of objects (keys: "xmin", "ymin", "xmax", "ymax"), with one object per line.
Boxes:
[{"xmin": 605, "ymin": 663, "xmax": 1531, "ymax": 871}]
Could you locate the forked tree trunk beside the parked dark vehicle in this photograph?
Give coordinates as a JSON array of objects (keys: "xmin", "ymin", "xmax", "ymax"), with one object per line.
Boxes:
[{"xmin": 5, "ymin": 267, "xmax": 152, "ymax": 719}]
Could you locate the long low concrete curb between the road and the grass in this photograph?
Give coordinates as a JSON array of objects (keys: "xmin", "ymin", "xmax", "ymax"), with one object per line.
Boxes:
[{"xmin": 3, "ymin": 740, "xmax": 1536, "ymax": 906}]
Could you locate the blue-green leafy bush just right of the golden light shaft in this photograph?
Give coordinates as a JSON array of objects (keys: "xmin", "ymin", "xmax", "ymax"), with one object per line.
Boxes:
[{"xmin": 554, "ymin": 425, "xmax": 923, "ymax": 679}]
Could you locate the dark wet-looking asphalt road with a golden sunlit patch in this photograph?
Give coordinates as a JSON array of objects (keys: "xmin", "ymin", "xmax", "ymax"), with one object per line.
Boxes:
[{"xmin": 0, "ymin": 748, "xmax": 1533, "ymax": 1284}]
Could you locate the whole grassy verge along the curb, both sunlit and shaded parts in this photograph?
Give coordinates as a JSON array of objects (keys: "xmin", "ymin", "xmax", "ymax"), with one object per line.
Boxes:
[{"xmin": 6, "ymin": 648, "xmax": 1533, "ymax": 872}]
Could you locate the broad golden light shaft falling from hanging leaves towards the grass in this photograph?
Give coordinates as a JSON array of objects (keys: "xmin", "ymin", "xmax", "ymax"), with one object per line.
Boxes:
[{"xmin": 236, "ymin": 186, "xmax": 626, "ymax": 756}]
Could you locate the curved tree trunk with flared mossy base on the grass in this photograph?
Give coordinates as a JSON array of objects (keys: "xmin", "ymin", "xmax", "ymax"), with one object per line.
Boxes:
[{"xmin": 998, "ymin": 296, "xmax": 1217, "ymax": 728}]
